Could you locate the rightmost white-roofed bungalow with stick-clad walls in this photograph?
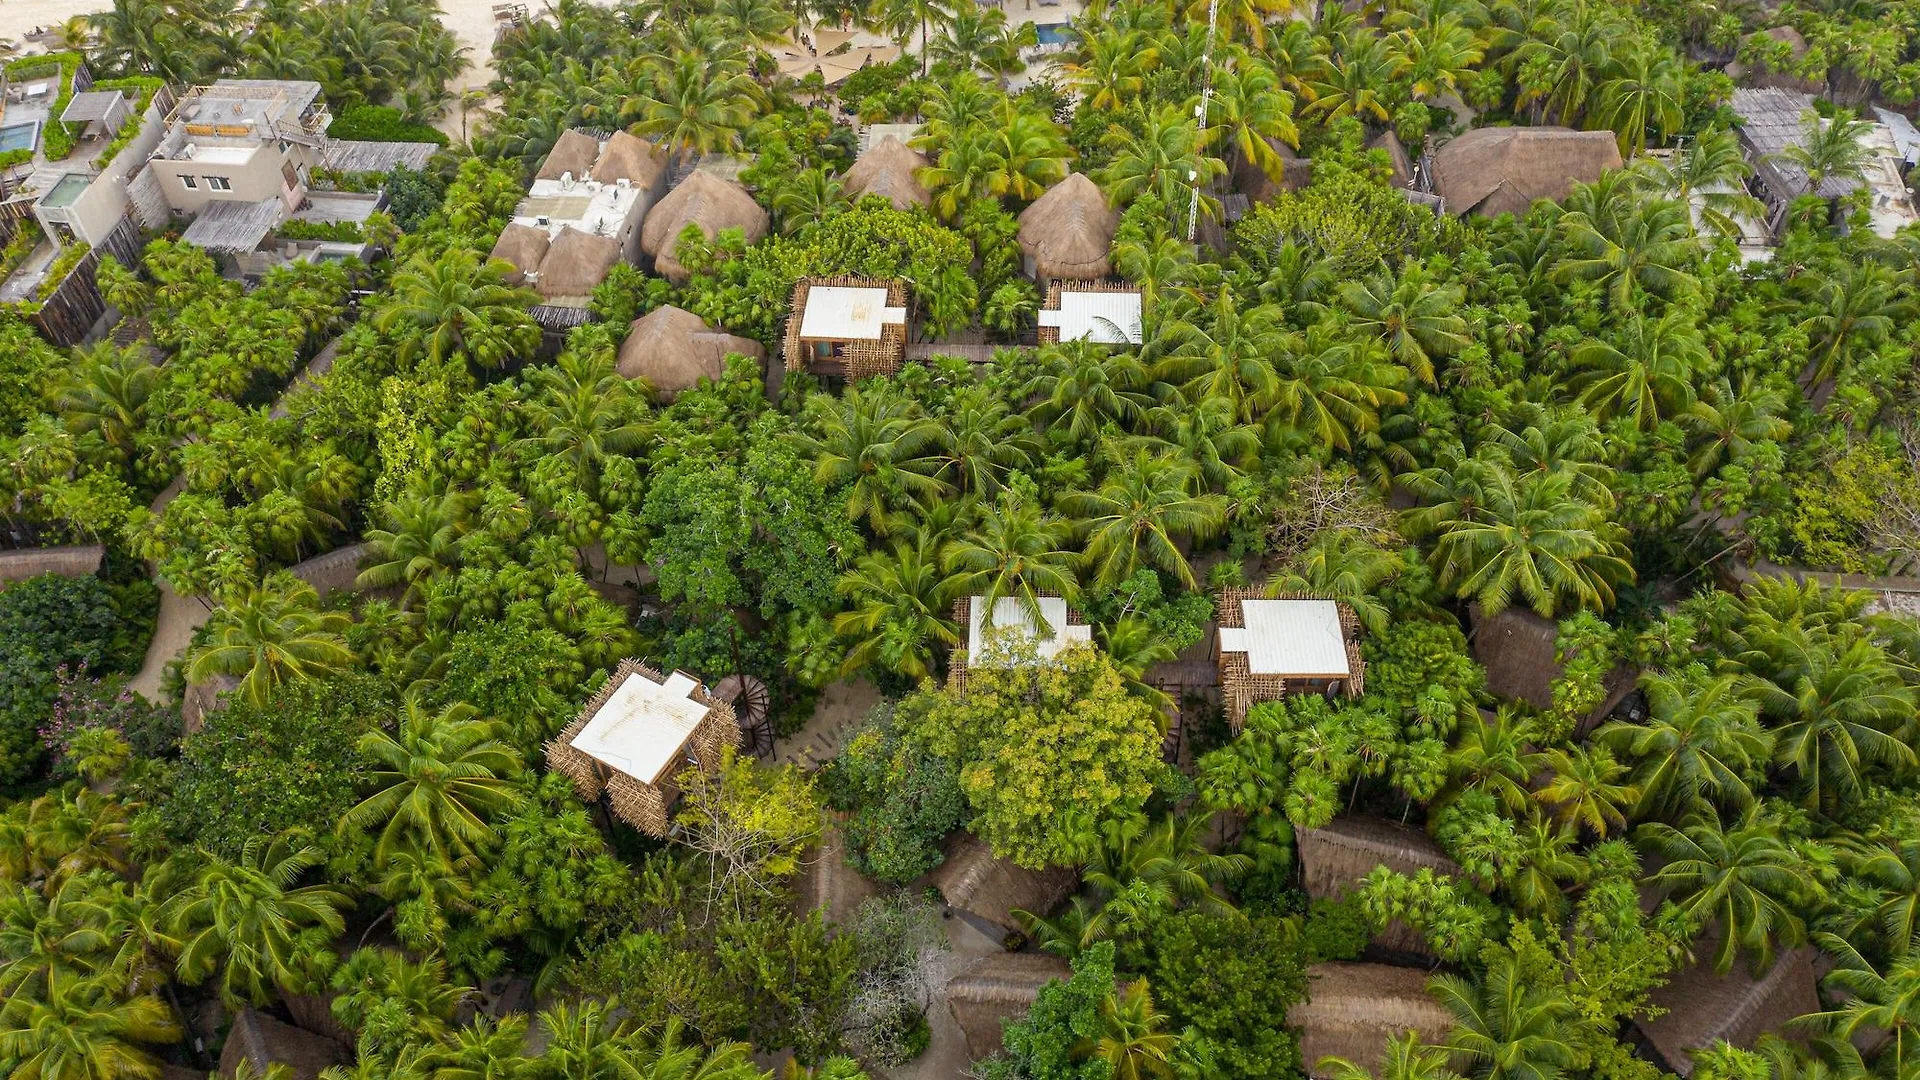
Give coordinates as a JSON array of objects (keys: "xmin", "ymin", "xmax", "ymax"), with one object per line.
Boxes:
[{"xmin": 1213, "ymin": 588, "xmax": 1367, "ymax": 730}]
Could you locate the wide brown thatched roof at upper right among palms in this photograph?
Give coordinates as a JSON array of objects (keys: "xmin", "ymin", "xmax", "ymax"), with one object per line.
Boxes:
[{"xmin": 1434, "ymin": 127, "xmax": 1620, "ymax": 217}]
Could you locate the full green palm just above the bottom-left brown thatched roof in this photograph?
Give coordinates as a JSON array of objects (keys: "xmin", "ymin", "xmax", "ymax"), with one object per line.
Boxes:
[{"xmin": 161, "ymin": 836, "xmax": 349, "ymax": 1009}]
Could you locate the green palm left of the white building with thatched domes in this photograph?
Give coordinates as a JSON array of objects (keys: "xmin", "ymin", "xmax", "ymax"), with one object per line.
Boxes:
[{"xmin": 374, "ymin": 248, "xmax": 540, "ymax": 367}]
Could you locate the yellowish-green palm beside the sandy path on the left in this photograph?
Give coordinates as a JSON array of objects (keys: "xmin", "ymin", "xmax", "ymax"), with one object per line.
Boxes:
[{"xmin": 186, "ymin": 573, "xmax": 353, "ymax": 705}]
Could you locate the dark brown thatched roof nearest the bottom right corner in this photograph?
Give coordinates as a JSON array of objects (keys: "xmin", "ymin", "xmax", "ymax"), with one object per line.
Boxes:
[{"xmin": 1634, "ymin": 928, "xmax": 1820, "ymax": 1076}]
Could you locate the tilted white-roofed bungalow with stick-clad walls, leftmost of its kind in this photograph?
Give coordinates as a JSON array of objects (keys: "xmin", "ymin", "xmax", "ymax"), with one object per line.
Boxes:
[{"xmin": 547, "ymin": 659, "xmax": 739, "ymax": 836}]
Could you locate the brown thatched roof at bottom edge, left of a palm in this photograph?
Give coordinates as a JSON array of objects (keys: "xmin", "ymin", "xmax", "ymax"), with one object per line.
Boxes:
[{"xmin": 1286, "ymin": 963, "xmax": 1453, "ymax": 1080}]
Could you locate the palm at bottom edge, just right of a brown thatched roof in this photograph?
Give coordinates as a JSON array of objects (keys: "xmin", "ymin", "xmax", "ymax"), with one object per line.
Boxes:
[{"xmin": 1427, "ymin": 951, "xmax": 1580, "ymax": 1080}]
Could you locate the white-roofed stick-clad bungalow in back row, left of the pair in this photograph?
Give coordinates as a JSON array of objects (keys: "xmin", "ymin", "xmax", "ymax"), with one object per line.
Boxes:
[{"xmin": 785, "ymin": 277, "xmax": 906, "ymax": 379}]
